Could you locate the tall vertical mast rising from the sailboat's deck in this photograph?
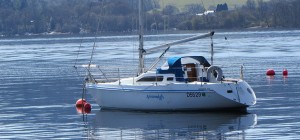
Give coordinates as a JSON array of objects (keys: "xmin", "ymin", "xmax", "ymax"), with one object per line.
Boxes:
[{"xmin": 138, "ymin": 0, "xmax": 145, "ymax": 75}]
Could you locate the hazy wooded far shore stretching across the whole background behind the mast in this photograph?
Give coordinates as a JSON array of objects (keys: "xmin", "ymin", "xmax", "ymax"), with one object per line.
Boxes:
[{"xmin": 0, "ymin": 0, "xmax": 300, "ymax": 36}]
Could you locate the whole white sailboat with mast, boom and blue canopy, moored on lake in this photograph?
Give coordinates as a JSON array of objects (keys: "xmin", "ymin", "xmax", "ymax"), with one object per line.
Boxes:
[{"xmin": 85, "ymin": 0, "xmax": 256, "ymax": 111}]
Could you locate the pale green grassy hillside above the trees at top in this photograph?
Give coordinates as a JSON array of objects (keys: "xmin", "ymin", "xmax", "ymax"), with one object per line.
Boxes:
[{"xmin": 159, "ymin": 0, "xmax": 247, "ymax": 9}]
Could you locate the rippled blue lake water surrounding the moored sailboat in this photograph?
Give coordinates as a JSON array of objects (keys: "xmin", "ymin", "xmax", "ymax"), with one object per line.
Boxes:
[{"xmin": 0, "ymin": 30, "xmax": 300, "ymax": 139}]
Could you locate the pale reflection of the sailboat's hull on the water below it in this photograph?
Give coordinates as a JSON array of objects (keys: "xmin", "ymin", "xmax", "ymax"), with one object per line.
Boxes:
[{"xmin": 88, "ymin": 111, "xmax": 257, "ymax": 139}]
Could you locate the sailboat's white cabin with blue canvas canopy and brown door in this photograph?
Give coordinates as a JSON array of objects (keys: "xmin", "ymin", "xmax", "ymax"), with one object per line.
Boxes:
[{"xmin": 136, "ymin": 56, "xmax": 222, "ymax": 83}]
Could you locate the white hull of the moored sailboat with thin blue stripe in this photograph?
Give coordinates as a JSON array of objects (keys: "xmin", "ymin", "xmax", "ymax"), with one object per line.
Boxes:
[{"xmin": 87, "ymin": 80, "xmax": 256, "ymax": 111}]
